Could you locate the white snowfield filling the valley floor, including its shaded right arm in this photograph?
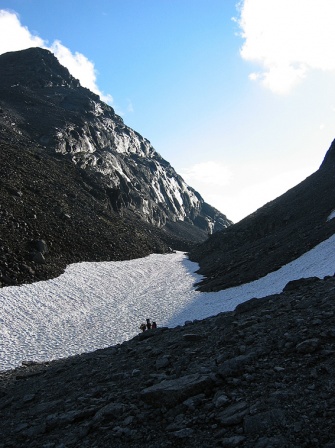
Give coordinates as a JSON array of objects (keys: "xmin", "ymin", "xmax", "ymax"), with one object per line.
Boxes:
[{"xmin": 0, "ymin": 235, "xmax": 335, "ymax": 370}]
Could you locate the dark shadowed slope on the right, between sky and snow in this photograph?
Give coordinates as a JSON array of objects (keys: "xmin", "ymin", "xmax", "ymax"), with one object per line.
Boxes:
[{"xmin": 190, "ymin": 140, "xmax": 335, "ymax": 291}]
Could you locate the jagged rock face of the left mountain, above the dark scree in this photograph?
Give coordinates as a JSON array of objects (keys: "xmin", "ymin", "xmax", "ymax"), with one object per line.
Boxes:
[{"xmin": 0, "ymin": 48, "xmax": 232, "ymax": 233}]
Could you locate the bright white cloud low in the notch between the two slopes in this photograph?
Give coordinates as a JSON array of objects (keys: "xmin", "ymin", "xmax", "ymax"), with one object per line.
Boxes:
[{"xmin": 179, "ymin": 160, "xmax": 312, "ymax": 222}]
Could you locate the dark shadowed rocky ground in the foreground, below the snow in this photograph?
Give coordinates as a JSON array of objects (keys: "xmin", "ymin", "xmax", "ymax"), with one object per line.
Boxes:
[{"xmin": 0, "ymin": 277, "xmax": 335, "ymax": 448}]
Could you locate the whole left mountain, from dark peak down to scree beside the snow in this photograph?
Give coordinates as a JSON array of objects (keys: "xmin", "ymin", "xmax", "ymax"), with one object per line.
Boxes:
[{"xmin": 0, "ymin": 48, "xmax": 231, "ymax": 286}]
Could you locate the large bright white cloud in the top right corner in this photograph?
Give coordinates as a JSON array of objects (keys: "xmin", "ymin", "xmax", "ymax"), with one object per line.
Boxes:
[{"xmin": 238, "ymin": 0, "xmax": 335, "ymax": 94}]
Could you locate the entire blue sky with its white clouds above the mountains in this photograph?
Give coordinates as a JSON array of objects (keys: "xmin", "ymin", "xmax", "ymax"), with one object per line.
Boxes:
[{"xmin": 0, "ymin": 0, "xmax": 335, "ymax": 222}]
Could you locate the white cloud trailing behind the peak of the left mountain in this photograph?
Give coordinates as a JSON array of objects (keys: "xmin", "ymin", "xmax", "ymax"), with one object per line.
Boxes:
[{"xmin": 0, "ymin": 10, "xmax": 113, "ymax": 104}]
